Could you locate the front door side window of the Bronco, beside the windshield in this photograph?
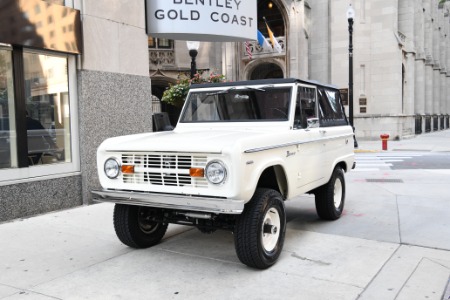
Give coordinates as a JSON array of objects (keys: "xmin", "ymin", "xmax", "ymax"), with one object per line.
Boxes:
[{"xmin": 294, "ymin": 86, "xmax": 317, "ymax": 129}]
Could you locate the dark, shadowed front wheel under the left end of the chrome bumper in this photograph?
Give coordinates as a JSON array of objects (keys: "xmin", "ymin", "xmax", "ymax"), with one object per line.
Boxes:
[{"xmin": 114, "ymin": 204, "xmax": 168, "ymax": 248}]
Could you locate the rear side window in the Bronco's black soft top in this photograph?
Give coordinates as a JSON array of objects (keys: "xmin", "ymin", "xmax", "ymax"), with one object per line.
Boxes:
[{"xmin": 318, "ymin": 88, "xmax": 347, "ymax": 126}]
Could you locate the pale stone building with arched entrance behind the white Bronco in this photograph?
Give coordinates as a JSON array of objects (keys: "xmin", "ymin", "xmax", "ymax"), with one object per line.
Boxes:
[{"xmin": 150, "ymin": 0, "xmax": 450, "ymax": 139}]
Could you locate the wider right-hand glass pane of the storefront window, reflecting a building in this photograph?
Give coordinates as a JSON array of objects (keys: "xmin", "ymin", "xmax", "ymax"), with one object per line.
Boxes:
[{"xmin": 23, "ymin": 52, "xmax": 71, "ymax": 166}]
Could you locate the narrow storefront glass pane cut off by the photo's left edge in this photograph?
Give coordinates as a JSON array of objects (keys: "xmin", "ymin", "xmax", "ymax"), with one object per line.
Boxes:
[{"xmin": 0, "ymin": 48, "xmax": 17, "ymax": 169}]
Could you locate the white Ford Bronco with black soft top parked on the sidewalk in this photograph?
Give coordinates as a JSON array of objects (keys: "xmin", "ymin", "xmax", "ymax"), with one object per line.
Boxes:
[{"xmin": 92, "ymin": 79, "xmax": 354, "ymax": 269}]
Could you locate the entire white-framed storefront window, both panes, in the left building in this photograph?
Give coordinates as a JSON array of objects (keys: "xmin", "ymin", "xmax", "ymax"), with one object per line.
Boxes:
[{"xmin": 0, "ymin": 49, "xmax": 79, "ymax": 185}]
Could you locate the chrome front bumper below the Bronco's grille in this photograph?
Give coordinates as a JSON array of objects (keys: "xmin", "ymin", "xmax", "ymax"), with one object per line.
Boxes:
[{"xmin": 91, "ymin": 190, "xmax": 244, "ymax": 214}]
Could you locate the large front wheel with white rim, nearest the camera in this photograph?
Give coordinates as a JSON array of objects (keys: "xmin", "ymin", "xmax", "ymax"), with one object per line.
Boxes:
[{"xmin": 234, "ymin": 188, "xmax": 286, "ymax": 269}]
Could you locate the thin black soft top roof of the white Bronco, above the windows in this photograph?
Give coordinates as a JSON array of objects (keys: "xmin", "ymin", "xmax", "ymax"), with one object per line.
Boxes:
[{"xmin": 191, "ymin": 78, "xmax": 338, "ymax": 90}]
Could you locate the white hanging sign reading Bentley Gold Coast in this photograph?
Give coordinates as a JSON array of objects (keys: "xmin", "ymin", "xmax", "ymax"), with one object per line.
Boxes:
[{"xmin": 146, "ymin": 0, "xmax": 257, "ymax": 42}]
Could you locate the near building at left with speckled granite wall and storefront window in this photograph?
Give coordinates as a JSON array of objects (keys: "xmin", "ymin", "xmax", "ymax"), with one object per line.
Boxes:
[{"xmin": 0, "ymin": 0, "xmax": 152, "ymax": 222}]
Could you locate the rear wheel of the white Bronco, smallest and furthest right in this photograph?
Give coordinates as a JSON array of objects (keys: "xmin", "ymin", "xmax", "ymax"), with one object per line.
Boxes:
[{"xmin": 315, "ymin": 167, "xmax": 345, "ymax": 220}]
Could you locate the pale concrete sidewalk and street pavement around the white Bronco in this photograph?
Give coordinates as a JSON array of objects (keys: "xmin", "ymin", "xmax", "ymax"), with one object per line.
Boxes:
[{"xmin": 0, "ymin": 130, "xmax": 450, "ymax": 300}]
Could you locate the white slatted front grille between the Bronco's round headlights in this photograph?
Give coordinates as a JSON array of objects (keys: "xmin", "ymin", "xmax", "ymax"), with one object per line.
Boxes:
[{"xmin": 122, "ymin": 153, "xmax": 207, "ymax": 188}]
